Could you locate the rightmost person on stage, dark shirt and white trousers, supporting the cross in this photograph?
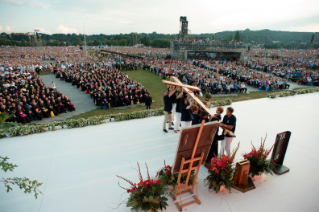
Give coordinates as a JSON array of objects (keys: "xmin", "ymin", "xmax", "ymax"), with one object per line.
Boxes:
[{"xmin": 219, "ymin": 107, "xmax": 236, "ymax": 155}]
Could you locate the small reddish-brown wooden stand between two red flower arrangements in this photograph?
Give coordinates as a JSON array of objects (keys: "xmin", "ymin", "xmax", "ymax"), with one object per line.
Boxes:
[{"xmin": 233, "ymin": 159, "xmax": 255, "ymax": 192}]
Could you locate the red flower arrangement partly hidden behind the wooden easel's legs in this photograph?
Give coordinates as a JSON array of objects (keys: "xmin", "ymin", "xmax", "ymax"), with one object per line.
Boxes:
[{"xmin": 156, "ymin": 161, "xmax": 195, "ymax": 190}]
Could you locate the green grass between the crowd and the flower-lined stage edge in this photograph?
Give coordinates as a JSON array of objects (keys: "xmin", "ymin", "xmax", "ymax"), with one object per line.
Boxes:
[{"xmin": 72, "ymin": 69, "xmax": 272, "ymax": 119}]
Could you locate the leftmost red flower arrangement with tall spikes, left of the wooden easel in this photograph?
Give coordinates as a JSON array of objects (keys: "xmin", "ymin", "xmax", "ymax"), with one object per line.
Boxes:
[{"xmin": 116, "ymin": 163, "xmax": 168, "ymax": 212}]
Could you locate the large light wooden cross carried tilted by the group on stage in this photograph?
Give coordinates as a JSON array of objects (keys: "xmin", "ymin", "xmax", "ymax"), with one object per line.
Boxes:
[{"xmin": 162, "ymin": 76, "xmax": 214, "ymax": 116}]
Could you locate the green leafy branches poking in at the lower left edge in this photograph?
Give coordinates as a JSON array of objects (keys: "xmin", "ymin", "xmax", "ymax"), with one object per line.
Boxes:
[{"xmin": 0, "ymin": 156, "xmax": 43, "ymax": 198}]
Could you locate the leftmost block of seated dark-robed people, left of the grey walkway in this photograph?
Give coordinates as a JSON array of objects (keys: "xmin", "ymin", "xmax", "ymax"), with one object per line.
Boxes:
[{"xmin": 0, "ymin": 72, "xmax": 75, "ymax": 124}]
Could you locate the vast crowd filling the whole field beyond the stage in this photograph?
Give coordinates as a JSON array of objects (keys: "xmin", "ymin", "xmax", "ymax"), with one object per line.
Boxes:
[{"xmin": 0, "ymin": 45, "xmax": 319, "ymax": 122}]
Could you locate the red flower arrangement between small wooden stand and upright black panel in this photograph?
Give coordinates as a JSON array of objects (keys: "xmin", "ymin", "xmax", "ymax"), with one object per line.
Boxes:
[{"xmin": 243, "ymin": 134, "xmax": 275, "ymax": 177}]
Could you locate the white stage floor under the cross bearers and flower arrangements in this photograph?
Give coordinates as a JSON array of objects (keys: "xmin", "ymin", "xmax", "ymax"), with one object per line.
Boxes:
[{"xmin": 0, "ymin": 93, "xmax": 319, "ymax": 212}]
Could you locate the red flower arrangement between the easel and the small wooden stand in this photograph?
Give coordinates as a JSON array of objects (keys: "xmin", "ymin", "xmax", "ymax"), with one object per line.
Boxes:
[{"xmin": 204, "ymin": 143, "xmax": 239, "ymax": 193}]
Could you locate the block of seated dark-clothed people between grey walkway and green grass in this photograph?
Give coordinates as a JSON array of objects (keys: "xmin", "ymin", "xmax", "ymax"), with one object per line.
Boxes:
[{"xmin": 56, "ymin": 66, "xmax": 147, "ymax": 109}]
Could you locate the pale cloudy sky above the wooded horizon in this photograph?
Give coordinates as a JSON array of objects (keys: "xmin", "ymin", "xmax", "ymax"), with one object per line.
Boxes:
[{"xmin": 0, "ymin": 0, "xmax": 319, "ymax": 34}]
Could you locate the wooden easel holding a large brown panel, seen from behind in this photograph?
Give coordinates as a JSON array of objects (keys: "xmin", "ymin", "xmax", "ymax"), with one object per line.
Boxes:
[{"xmin": 170, "ymin": 121, "xmax": 218, "ymax": 211}]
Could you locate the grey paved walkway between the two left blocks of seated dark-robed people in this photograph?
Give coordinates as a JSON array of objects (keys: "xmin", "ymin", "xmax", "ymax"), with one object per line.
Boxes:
[{"xmin": 31, "ymin": 74, "xmax": 98, "ymax": 124}]
